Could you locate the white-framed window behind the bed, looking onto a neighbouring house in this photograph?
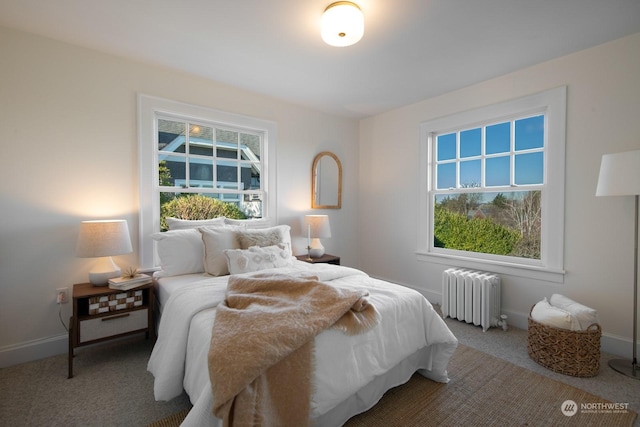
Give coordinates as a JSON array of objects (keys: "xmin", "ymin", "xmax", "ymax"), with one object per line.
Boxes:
[{"xmin": 138, "ymin": 95, "xmax": 277, "ymax": 267}]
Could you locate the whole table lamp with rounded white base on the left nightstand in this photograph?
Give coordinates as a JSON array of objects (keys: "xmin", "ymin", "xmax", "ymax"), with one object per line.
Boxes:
[{"xmin": 76, "ymin": 219, "xmax": 133, "ymax": 286}]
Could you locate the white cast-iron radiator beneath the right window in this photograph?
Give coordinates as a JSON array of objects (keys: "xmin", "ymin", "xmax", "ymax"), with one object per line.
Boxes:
[{"xmin": 442, "ymin": 268, "xmax": 506, "ymax": 332}]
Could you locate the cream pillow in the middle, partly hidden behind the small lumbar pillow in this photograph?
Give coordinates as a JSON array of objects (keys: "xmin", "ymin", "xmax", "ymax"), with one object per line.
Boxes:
[{"xmin": 198, "ymin": 226, "xmax": 242, "ymax": 276}]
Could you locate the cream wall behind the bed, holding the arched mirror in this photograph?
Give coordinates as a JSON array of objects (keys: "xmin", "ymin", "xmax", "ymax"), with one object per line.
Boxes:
[{"xmin": 0, "ymin": 27, "xmax": 358, "ymax": 367}]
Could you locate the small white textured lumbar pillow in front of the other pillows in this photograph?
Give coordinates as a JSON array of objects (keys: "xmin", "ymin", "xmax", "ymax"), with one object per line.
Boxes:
[{"xmin": 224, "ymin": 245, "xmax": 292, "ymax": 274}]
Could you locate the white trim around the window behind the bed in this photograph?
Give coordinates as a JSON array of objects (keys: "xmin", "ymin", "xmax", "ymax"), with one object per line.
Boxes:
[{"xmin": 138, "ymin": 94, "xmax": 278, "ymax": 268}]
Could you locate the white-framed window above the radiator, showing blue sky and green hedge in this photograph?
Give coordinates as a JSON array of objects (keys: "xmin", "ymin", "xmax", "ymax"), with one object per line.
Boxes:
[{"xmin": 417, "ymin": 87, "xmax": 566, "ymax": 281}]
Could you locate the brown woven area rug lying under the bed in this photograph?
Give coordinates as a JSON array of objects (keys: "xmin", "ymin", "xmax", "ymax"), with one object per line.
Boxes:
[{"xmin": 146, "ymin": 345, "xmax": 636, "ymax": 427}]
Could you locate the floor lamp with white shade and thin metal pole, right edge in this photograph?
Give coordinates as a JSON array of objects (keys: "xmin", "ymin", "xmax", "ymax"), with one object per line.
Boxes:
[{"xmin": 596, "ymin": 150, "xmax": 640, "ymax": 380}]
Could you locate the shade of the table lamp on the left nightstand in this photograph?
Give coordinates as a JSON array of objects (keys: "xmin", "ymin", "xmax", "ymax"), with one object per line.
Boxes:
[{"xmin": 76, "ymin": 219, "xmax": 133, "ymax": 258}]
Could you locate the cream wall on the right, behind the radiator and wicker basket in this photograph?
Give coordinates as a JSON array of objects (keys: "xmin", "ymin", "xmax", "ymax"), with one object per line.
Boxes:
[{"xmin": 359, "ymin": 34, "xmax": 640, "ymax": 357}]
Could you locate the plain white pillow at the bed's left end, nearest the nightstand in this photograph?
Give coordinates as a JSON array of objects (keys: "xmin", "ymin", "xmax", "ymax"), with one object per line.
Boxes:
[{"xmin": 151, "ymin": 229, "xmax": 204, "ymax": 277}]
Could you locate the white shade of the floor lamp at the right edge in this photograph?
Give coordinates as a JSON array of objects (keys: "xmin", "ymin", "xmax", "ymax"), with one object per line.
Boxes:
[{"xmin": 596, "ymin": 150, "xmax": 640, "ymax": 196}]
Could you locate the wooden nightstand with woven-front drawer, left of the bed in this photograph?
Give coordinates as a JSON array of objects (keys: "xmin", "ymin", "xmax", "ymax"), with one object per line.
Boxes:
[{"xmin": 68, "ymin": 283, "xmax": 155, "ymax": 378}]
